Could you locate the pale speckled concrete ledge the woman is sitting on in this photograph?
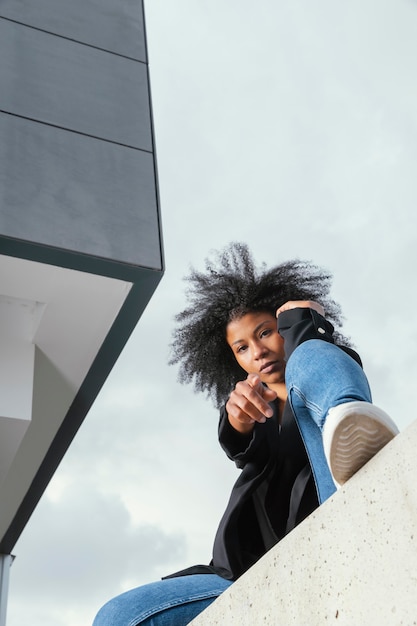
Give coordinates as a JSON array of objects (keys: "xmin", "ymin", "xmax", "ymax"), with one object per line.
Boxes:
[{"xmin": 192, "ymin": 422, "xmax": 417, "ymax": 626}]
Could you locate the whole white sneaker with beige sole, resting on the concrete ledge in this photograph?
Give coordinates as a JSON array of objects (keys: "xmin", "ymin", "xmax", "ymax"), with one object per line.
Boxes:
[{"xmin": 323, "ymin": 402, "xmax": 399, "ymax": 487}]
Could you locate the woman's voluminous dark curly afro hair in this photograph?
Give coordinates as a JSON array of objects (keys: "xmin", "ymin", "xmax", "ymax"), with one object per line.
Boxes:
[{"xmin": 169, "ymin": 243, "xmax": 350, "ymax": 406}]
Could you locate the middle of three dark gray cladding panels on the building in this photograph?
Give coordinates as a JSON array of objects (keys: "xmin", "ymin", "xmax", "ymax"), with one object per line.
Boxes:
[{"xmin": 0, "ymin": 19, "xmax": 152, "ymax": 150}]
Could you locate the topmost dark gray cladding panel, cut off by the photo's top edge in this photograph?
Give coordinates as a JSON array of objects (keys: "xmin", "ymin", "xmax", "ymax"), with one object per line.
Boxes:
[{"xmin": 0, "ymin": 0, "xmax": 147, "ymax": 62}]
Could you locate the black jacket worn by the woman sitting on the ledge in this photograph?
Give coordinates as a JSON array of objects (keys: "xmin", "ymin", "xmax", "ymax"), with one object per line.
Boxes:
[{"xmin": 164, "ymin": 308, "xmax": 360, "ymax": 580}]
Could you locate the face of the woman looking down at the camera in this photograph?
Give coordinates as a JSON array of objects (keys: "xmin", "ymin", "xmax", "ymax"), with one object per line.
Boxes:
[{"xmin": 226, "ymin": 312, "xmax": 285, "ymax": 384}]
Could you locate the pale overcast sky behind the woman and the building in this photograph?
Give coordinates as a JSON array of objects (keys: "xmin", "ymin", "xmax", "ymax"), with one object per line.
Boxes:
[{"xmin": 8, "ymin": 0, "xmax": 417, "ymax": 626}]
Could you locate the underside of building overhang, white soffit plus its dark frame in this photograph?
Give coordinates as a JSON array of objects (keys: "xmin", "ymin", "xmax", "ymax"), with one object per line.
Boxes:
[{"xmin": 0, "ymin": 237, "xmax": 163, "ymax": 554}]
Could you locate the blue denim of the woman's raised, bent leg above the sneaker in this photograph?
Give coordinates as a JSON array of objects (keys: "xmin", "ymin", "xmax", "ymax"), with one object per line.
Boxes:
[{"xmin": 285, "ymin": 339, "xmax": 372, "ymax": 504}]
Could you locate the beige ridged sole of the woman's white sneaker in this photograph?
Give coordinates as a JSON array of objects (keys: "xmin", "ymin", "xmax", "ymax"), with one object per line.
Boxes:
[{"xmin": 329, "ymin": 414, "xmax": 397, "ymax": 485}]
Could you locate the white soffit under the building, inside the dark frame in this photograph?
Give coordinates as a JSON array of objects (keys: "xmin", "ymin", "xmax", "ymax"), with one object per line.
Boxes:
[{"xmin": 0, "ymin": 255, "xmax": 132, "ymax": 536}]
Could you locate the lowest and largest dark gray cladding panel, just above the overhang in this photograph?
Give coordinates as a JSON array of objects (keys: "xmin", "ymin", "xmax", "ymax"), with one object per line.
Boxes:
[{"xmin": 0, "ymin": 114, "xmax": 162, "ymax": 270}]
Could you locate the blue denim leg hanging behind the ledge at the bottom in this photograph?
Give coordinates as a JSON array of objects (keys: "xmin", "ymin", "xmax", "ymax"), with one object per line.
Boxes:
[{"xmin": 93, "ymin": 574, "xmax": 232, "ymax": 626}]
